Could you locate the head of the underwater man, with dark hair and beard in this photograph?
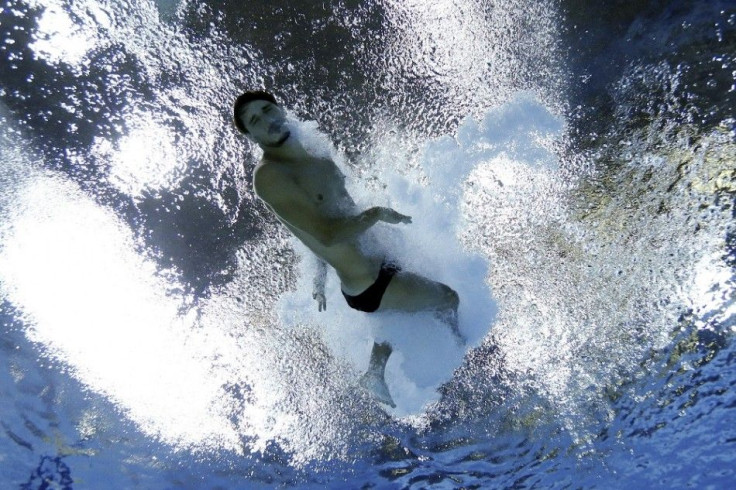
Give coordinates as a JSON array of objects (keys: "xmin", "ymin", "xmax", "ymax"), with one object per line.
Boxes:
[{"xmin": 233, "ymin": 90, "xmax": 291, "ymax": 148}]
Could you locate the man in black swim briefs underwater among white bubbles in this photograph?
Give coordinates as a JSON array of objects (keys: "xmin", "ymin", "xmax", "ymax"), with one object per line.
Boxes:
[{"xmin": 234, "ymin": 91, "xmax": 464, "ymax": 407}]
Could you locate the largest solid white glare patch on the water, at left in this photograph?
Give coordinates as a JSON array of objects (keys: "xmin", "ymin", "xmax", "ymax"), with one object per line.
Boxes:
[{"xmin": 0, "ymin": 167, "xmax": 239, "ymax": 447}]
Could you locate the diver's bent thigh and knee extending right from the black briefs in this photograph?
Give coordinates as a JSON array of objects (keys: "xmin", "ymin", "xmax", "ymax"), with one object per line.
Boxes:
[{"xmin": 379, "ymin": 271, "xmax": 465, "ymax": 344}]
